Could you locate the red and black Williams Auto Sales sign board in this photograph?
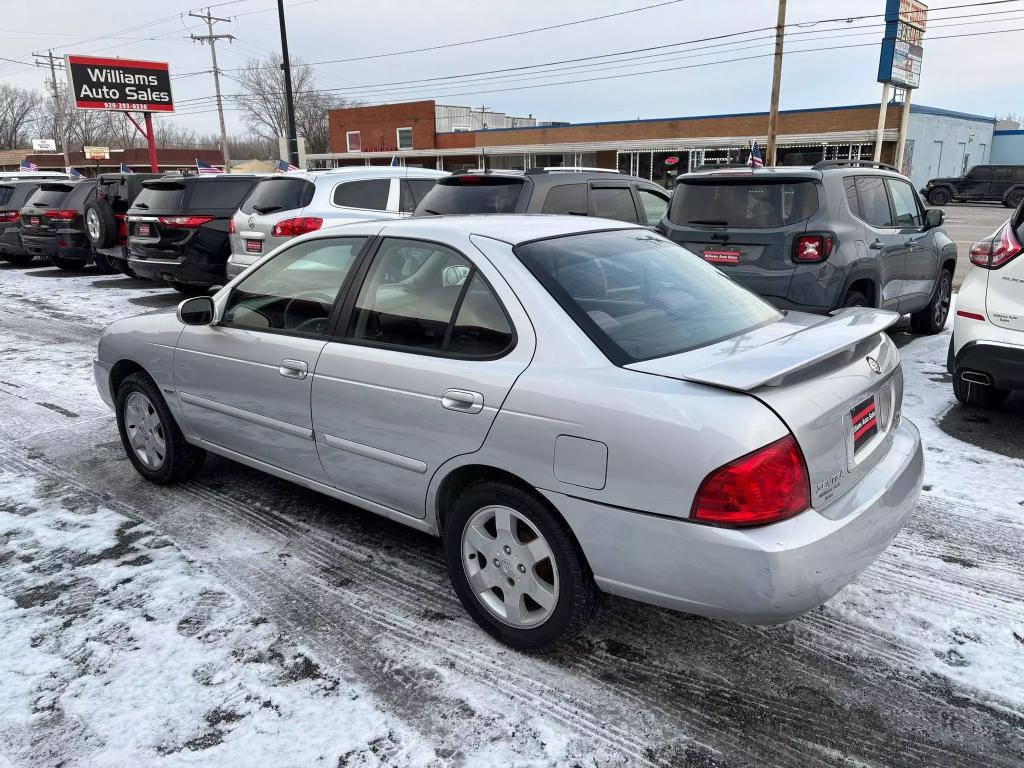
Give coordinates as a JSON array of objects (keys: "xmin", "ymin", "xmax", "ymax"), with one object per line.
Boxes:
[{"xmin": 65, "ymin": 55, "xmax": 174, "ymax": 112}]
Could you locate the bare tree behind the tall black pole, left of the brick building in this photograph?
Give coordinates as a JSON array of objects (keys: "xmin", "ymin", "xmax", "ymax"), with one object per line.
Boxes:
[{"xmin": 234, "ymin": 56, "xmax": 350, "ymax": 153}]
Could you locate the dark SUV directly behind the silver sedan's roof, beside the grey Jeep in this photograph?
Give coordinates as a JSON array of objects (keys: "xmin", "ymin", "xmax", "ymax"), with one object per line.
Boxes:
[{"xmin": 414, "ymin": 168, "xmax": 669, "ymax": 226}]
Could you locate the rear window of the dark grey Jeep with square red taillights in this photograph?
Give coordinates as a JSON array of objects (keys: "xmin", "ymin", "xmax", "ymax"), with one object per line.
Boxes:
[{"xmin": 669, "ymin": 179, "xmax": 818, "ymax": 229}]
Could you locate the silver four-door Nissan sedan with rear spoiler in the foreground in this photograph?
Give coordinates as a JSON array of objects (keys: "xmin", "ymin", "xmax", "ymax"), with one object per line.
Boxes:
[{"xmin": 95, "ymin": 216, "xmax": 924, "ymax": 651}]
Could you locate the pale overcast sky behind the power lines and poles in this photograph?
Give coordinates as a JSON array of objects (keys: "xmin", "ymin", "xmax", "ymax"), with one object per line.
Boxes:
[{"xmin": 0, "ymin": 0, "xmax": 1024, "ymax": 140}]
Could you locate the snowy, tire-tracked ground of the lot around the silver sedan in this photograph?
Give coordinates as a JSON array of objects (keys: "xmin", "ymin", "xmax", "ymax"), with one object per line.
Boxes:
[{"xmin": 0, "ymin": 264, "xmax": 1024, "ymax": 768}]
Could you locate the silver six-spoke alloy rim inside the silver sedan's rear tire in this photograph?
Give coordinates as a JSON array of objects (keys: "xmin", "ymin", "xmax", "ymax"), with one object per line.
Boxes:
[{"xmin": 462, "ymin": 506, "xmax": 558, "ymax": 629}]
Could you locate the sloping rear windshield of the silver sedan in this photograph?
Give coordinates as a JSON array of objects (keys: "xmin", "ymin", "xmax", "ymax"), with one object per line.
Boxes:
[{"xmin": 516, "ymin": 229, "xmax": 782, "ymax": 366}]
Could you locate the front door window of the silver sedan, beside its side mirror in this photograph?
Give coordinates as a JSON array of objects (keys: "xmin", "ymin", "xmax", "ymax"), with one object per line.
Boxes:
[{"xmin": 221, "ymin": 238, "xmax": 366, "ymax": 335}]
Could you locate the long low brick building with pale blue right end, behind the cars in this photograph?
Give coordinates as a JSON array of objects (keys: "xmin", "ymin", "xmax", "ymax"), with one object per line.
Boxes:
[{"xmin": 317, "ymin": 100, "xmax": 994, "ymax": 183}]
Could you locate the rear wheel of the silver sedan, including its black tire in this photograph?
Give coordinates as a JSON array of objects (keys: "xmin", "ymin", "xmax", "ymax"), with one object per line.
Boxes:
[{"xmin": 444, "ymin": 481, "xmax": 601, "ymax": 653}]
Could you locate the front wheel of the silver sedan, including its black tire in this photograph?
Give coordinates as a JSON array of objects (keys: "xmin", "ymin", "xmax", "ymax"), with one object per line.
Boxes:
[{"xmin": 115, "ymin": 373, "xmax": 206, "ymax": 485}]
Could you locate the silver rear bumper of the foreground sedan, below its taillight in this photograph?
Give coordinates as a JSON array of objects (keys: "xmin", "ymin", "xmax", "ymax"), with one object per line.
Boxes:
[{"xmin": 545, "ymin": 420, "xmax": 925, "ymax": 624}]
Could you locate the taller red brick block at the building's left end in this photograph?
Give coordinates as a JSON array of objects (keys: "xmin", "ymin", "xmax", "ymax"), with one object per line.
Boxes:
[{"xmin": 330, "ymin": 100, "xmax": 435, "ymax": 152}]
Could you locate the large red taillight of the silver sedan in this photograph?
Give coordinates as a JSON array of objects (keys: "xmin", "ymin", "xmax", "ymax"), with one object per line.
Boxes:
[{"xmin": 690, "ymin": 434, "xmax": 811, "ymax": 527}]
